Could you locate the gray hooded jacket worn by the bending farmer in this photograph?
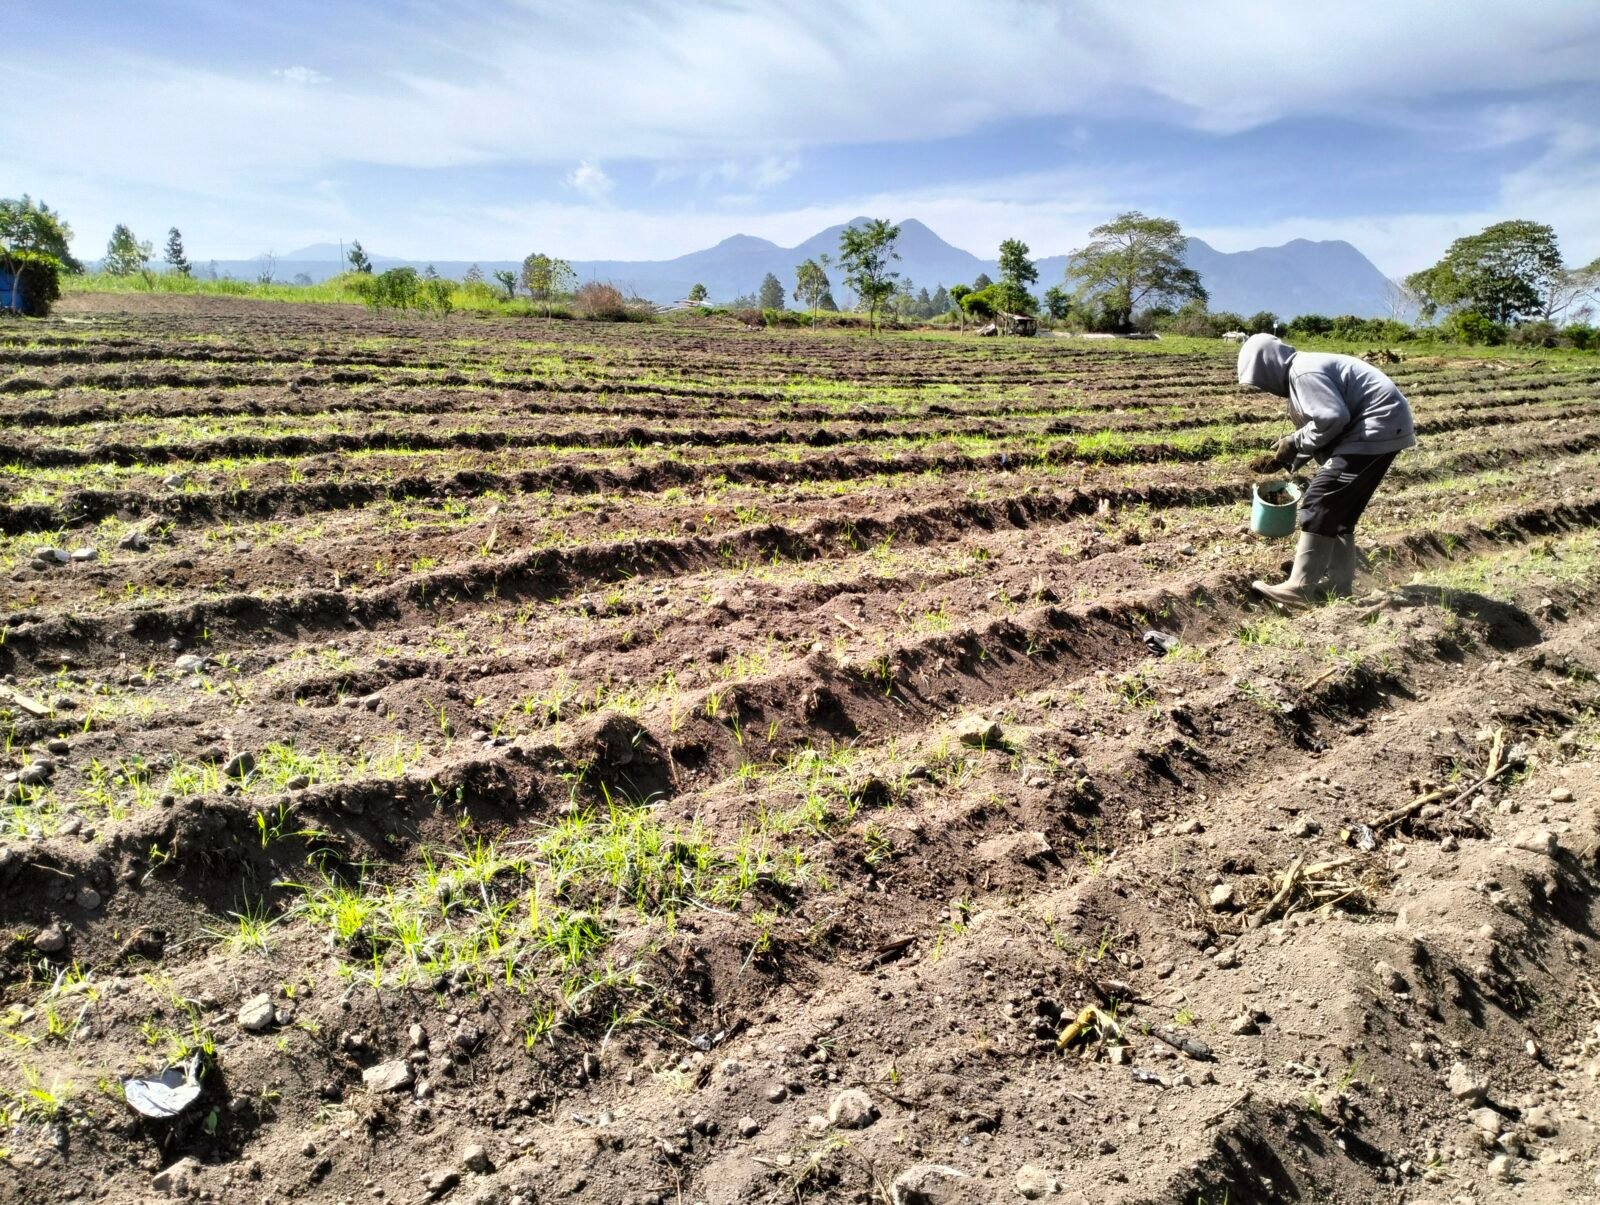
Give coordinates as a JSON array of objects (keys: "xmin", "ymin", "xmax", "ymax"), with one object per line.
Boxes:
[{"xmin": 1238, "ymin": 334, "xmax": 1416, "ymax": 461}]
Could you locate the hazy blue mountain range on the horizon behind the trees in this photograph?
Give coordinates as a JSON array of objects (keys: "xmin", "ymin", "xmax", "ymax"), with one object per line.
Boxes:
[{"xmin": 181, "ymin": 218, "xmax": 1387, "ymax": 318}]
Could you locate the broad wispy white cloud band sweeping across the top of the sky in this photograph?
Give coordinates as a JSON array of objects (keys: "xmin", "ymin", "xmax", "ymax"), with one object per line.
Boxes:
[{"xmin": 15, "ymin": 0, "xmax": 1600, "ymax": 178}]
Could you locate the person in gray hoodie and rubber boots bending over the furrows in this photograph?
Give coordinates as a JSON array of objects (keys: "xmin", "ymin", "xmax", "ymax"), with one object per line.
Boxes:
[{"xmin": 1238, "ymin": 334, "xmax": 1416, "ymax": 608}]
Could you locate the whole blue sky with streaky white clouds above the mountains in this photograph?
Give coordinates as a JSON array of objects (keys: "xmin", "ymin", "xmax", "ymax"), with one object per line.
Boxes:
[{"xmin": 12, "ymin": 0, "xmax": 1600, "ymax": 274}]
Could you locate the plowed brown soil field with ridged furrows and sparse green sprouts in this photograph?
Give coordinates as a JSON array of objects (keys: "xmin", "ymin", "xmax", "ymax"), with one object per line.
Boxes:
[{"xmin": 0, "ymin": 298, "xmax": 1600, "ymax": 1205}]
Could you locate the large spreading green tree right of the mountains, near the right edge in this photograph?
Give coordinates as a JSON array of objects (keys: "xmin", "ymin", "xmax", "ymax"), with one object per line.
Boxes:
[{"xmin": 1405, "ymin": 221, "xmax": 1565, "ymax": 325}]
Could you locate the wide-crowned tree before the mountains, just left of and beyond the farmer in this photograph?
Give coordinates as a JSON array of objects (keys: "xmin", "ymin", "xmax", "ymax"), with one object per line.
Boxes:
[{"xmin": 1067, "ymin": 210, "xmax": 1206, "ymax": 331}]
